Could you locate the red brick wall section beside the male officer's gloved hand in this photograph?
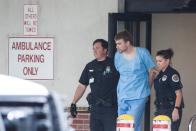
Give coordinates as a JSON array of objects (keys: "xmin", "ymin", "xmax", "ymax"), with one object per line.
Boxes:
[{"xmin": 72, "ymin": 109, "xmax": 90, "ymax": 131}]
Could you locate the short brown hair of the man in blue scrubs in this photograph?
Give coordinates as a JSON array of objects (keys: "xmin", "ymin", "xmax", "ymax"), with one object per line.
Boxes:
[{"xmin": 114, "ymin": 30, "xmax": 133, "ymax": 44}]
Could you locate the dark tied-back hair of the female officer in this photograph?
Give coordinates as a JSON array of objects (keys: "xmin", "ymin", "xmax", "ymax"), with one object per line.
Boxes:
[{"xmin": 156, "ymin": 48, "xmax": 174, "ymax": 59}]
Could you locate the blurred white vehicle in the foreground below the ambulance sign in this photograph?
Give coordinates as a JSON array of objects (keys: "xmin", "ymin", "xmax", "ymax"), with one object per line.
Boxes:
[{"xmin": 0, "ymin": 75, "xmax": 74, "ymax": 131}]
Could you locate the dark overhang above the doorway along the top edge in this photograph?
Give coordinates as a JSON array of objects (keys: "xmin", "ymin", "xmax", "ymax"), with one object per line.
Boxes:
[{"xmin": 125, "ymin": 0, "xmax": 196, "ymax": 13}]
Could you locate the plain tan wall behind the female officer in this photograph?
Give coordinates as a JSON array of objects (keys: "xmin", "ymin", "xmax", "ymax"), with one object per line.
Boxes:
[{"xmin": 152, "ymin": 14, "xmax": 196, "ymax": 131}]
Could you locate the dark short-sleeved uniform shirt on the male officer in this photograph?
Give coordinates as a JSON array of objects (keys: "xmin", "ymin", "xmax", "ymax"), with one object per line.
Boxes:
[{"xmin": 79, "ymin": 57, "xmax": 119, "ymax": 106}]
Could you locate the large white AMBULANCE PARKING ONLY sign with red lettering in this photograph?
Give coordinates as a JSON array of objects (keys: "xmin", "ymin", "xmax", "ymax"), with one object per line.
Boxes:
[{"xmin": 9, "ymin": 37, "xmax": 54, "ymax": 80}]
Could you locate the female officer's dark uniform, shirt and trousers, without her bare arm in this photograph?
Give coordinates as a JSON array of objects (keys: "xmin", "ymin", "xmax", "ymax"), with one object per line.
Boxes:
[{"xmin": 154, "ymin": 66, "xmax": 184, "ymax": 131}]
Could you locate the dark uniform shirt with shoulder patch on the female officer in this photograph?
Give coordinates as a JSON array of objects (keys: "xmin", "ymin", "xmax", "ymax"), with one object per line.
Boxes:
[{"xmin": 154, "ymin": 66, "xmax": 183, "ymax": 107}]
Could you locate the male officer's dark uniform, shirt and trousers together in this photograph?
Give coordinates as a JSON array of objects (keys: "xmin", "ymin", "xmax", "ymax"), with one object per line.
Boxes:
[{"xmin": 79, "ymin": 58, "xmax": 119, "ymax": 131}]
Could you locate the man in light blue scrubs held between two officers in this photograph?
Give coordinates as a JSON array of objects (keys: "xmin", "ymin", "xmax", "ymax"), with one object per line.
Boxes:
[{"xmin": 115, "ymin": 31, "xmax": 155, "ymax": 131}]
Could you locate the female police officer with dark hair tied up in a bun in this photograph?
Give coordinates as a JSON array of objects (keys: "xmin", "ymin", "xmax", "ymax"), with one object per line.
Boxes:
[{"xmin": 154, "ymin": 49, "xmax": 184, "ymax": 131}]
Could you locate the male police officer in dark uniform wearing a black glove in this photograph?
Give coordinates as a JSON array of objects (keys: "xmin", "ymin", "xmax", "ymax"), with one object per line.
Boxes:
[{"xmin": 71, "ymin": 39, "xmax": 119, "ymax": 131}]
